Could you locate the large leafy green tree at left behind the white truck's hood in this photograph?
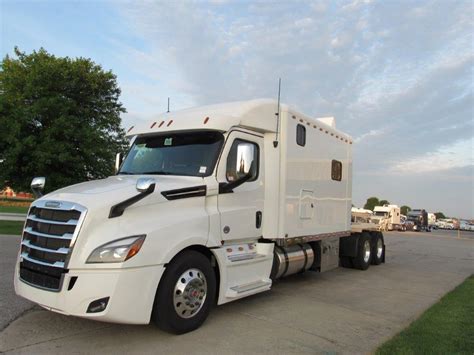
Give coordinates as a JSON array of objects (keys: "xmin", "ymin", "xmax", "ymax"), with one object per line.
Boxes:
[{"xmin": 0, "ymin": 48, "xmax": 126, "ymax": 191}]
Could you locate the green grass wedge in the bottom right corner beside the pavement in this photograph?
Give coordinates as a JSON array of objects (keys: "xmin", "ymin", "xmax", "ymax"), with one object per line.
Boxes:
[{"xmin": 376, "ymin": 275, "xmax": 474, "ymax": 355}]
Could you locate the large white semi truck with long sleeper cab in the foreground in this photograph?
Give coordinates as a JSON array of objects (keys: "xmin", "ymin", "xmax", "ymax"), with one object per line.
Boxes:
[{"xmin": 14, "ymin": 100, "xmax": 385, "ymax": 333}]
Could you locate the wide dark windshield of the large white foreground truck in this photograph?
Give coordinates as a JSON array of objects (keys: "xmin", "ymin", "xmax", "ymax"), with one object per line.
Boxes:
[{"xmin": 118, "ymin": 131, "xmax": 224, "ymax": 176}]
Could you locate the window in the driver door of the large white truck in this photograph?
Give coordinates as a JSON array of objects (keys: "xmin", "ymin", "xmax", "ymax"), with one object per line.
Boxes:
[{"xmin": 226, "ymin": 139, "xmax": 259, "ymax": 181}]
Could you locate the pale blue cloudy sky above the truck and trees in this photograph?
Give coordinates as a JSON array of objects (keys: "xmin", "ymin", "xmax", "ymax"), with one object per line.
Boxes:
[{"xmin": 0, "ymin": 0, "xmax": 474, "ymax": 218}]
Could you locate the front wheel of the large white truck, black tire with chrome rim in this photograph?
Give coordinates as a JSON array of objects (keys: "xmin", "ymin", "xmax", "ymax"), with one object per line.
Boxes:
[{"xmin": 151, "ymin": 250, "xmax": 216, "ymax": 334}]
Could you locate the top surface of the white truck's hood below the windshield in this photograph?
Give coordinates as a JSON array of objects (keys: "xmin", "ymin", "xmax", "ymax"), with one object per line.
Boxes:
[{"xmin": 38, "ymin": 175, "xmax": 205, "ymax": 210}]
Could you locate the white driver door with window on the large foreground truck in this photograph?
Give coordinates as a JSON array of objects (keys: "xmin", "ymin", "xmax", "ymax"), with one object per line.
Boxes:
[{"xmin": 217, "ymin": 131, "xmax": 264, "ymax": 241}]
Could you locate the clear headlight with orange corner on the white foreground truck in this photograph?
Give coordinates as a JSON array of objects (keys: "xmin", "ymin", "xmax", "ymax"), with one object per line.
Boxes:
[{"xmin": 86, "ymin": 235, "xmax": 145, "ymax": 264}]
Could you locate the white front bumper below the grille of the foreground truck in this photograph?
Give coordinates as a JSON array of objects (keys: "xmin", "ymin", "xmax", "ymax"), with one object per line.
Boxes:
[{"xmin": 14, "ymin": 264, "xmax": 164, "ymax": 324}]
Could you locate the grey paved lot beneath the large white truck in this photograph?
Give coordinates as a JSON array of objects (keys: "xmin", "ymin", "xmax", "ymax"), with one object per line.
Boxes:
[{"xmin": 0, "ymin": 231, "xmax": 474, "ymax": 354}]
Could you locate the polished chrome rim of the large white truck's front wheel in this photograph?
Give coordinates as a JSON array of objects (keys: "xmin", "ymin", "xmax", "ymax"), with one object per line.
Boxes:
[{"xmin": 173, "ymin": 269, "xmax": 207, "ymax": 318}]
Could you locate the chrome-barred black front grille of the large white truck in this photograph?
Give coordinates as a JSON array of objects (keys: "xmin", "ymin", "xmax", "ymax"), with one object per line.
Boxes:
[{"xmin": 20, "ymin": 201, "xmax": 87, "ymax": 291}]
